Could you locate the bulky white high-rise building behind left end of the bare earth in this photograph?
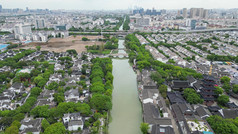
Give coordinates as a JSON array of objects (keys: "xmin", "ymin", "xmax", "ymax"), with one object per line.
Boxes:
[{"xmin": 14, "ymin": 24, "xmax": 32, "ymax": 35}]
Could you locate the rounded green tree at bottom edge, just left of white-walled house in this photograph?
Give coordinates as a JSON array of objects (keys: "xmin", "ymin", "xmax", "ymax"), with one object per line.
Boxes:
[{"xmin": 44, "ymin": 122, "xmax": 66, "ymax": 134}]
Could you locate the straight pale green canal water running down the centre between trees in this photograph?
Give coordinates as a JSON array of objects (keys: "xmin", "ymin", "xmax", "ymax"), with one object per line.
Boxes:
[{"xmin": 109, "ymin": 40, "xmax": 142, "ymax": 134}]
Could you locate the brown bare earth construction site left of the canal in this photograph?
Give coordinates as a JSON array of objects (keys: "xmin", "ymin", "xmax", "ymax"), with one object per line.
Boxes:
[{"xmin": 19, "ymin": 35, "xmax": 104, "ymax": 53}]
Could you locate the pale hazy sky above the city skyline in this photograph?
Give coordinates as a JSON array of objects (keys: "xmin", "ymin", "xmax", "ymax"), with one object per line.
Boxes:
[{"xmin": 0, "ymin": 0, "xmax": 238, "ymax": 10}]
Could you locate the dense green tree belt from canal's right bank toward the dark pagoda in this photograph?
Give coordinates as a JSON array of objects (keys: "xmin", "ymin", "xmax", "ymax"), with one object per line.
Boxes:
[{"xmin": 125, "ymin": 34, "xmax": 202, "ymax": 80}]
